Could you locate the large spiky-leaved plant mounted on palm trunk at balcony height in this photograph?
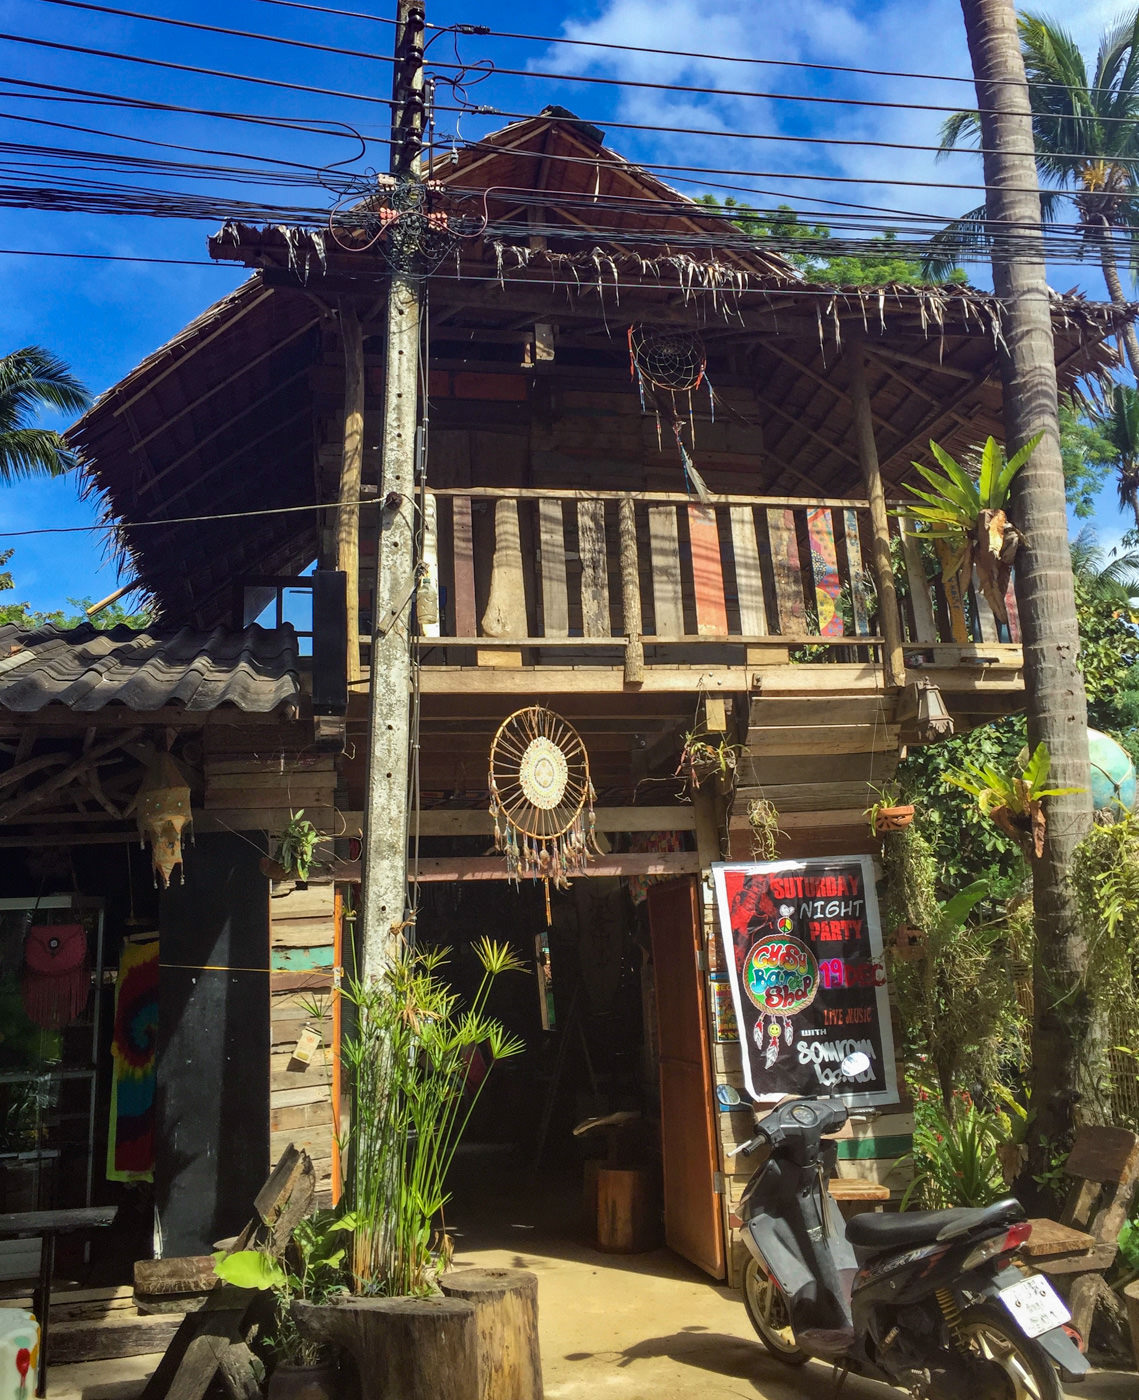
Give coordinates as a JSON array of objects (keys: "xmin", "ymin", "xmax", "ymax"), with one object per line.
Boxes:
[{"xmin": 896, "ymin": 433, "xmax": 1044, "ymax": 623}]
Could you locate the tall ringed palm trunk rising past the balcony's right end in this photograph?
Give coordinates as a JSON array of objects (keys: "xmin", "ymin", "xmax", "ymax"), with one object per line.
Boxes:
[{"xmin": 961, "ymin": 0, "xmax": 1091, "ymax": 1186}]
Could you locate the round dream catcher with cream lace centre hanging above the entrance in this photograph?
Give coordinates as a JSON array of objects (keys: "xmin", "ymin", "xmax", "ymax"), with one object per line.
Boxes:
[{"xmin": 490, "ymin": 706, "xmax": 597, "ymax": 914}]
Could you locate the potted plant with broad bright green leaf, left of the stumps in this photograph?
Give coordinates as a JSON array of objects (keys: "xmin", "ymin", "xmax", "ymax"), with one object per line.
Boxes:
[{"xmin": 214, "ymin": 1211, "xmax": 355, "ymax": 1400}]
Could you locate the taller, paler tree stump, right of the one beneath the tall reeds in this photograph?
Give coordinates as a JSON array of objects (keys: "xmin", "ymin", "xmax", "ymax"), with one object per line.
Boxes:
[{"xmin": 439, "ymin": 1268, "xmax": 543, "ymax": 1400}]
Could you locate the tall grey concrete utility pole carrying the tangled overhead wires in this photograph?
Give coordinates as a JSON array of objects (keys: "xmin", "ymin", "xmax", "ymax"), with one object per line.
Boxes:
[{"xmin": 361, "ymin": 0, "xmax": 424, "ymax": 977}]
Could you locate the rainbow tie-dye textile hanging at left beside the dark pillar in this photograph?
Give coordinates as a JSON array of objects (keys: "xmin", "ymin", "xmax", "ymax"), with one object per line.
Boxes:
[{"xmin": 106, "ymin": 938, "xmax": 158, "ymax": 1182}]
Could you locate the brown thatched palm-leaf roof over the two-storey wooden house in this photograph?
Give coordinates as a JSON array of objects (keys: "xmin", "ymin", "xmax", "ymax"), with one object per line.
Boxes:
[{"xmin": 70, "ymin": 118, "xmax": 1132, "ymax": 627}]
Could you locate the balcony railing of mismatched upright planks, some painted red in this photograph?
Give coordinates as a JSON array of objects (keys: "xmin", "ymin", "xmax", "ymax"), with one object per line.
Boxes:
[{"xmin": 421, "ymin": 487, "xmax": 1019, "ymax": 671}]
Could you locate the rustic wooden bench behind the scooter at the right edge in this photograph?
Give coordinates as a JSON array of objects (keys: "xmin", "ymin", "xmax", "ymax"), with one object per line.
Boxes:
[{"xmin": 1020, "ymin": 1127, "xmax": 1139, "ymax": 1338}]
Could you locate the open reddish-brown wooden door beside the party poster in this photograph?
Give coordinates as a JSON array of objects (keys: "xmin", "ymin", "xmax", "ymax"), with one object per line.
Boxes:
[{"xmin": 649, "ymin": 876, "xmax": 723, "ymax": 1278}]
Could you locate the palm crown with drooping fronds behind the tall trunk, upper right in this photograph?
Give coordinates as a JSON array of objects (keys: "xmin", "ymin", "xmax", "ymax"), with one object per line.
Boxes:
[{"xmin": 924, "ymin": 8, "xmax": 1139, "ymax": 377}]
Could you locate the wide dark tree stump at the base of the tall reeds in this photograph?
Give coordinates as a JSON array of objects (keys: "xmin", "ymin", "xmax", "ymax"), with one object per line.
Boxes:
[{"xmin": 292, "ymin": 1298, "xmax": 480, "ymax": 1400}]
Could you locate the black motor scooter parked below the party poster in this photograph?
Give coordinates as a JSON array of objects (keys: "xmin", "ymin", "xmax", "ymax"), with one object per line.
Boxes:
[{"xmin": 736, "ymin": 1051, "xmax": 1089, "ymax": 1400}]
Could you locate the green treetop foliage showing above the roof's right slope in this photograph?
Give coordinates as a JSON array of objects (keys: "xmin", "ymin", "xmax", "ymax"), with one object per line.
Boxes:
[{"xmin": 700, "ymin": 195, "xmax": 965, "ymax": 287}]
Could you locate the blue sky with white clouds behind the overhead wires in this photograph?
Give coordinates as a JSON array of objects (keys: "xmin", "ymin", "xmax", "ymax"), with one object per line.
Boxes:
[{"xmin": 0, "ymin": 0, "xmax": 1126, "ymax": 609}]
